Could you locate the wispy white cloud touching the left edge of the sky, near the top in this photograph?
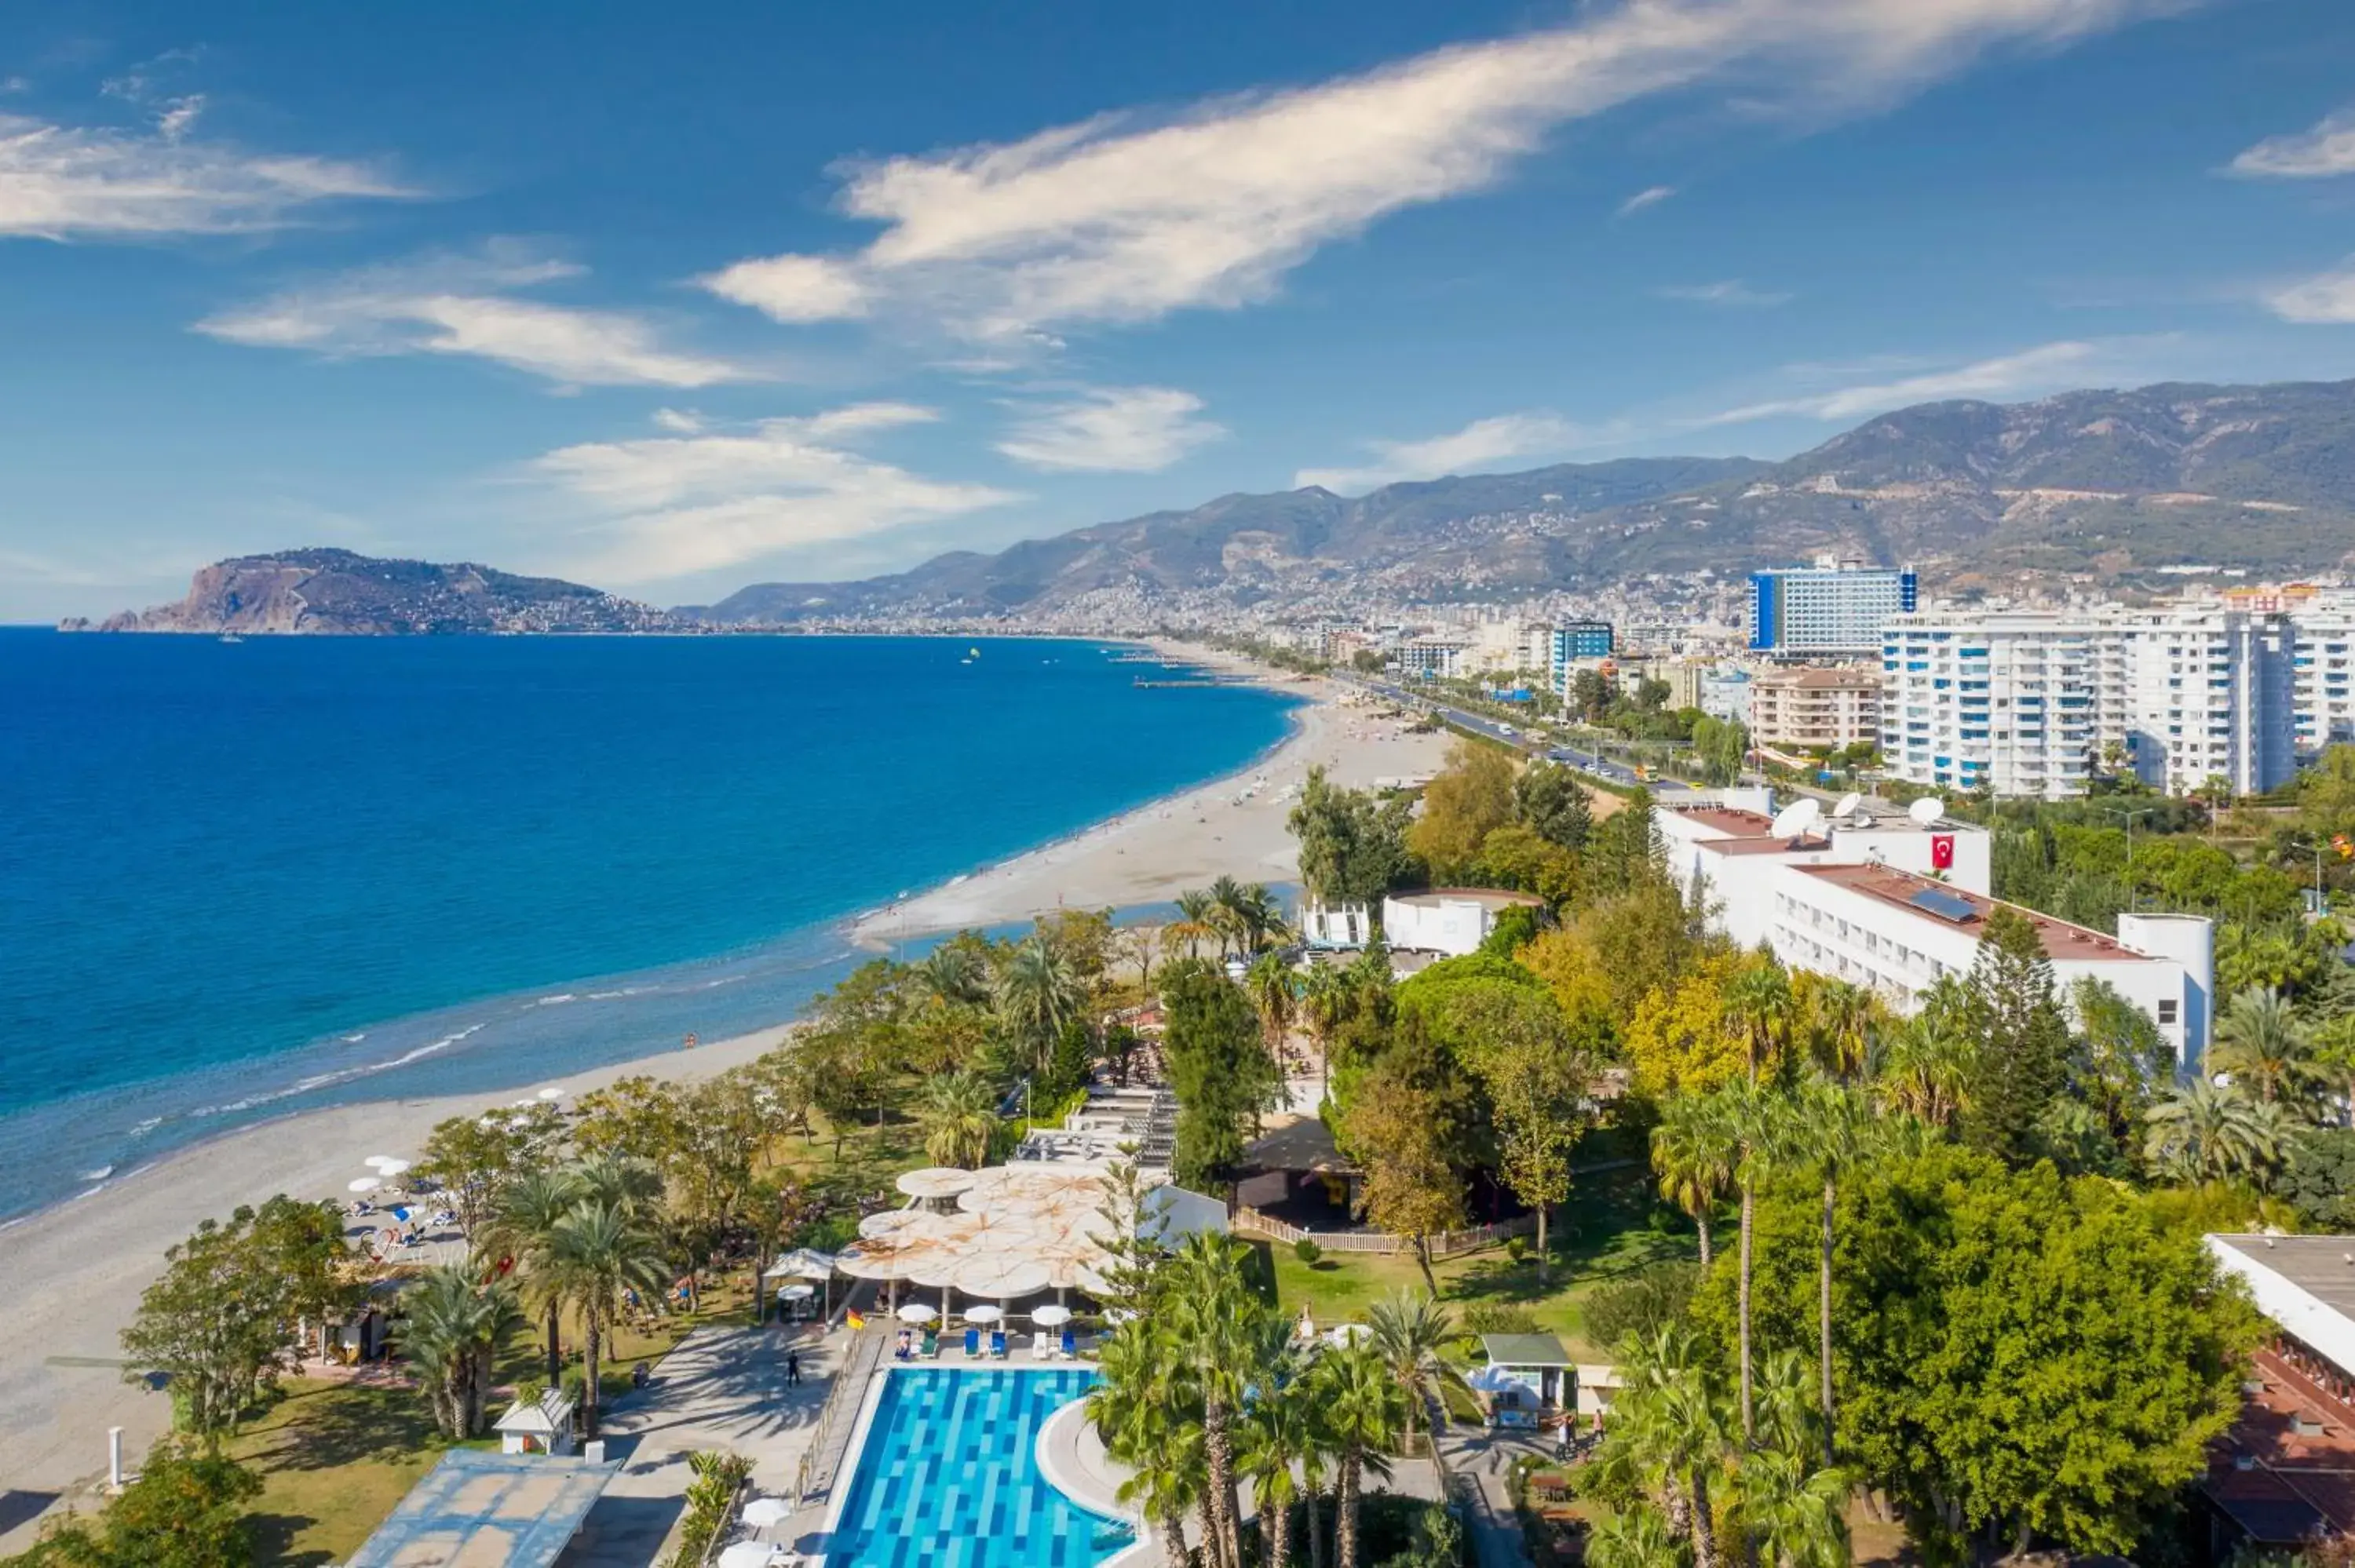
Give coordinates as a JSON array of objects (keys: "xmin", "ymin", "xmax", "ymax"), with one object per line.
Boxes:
[{"xmin": 0, "ymin": 99, "xmax": 417, "ymax": 240}]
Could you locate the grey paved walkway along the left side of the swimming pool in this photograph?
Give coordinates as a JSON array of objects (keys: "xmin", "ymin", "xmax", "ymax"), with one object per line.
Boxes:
[{"xmin": 563, "ymin": 1323, "xmax": 845, "ymax": 1568}]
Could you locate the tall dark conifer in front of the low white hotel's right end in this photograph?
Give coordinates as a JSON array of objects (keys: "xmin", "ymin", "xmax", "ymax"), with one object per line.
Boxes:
[{"xmin": 1964, "ymin": 904, "xmax": 2068, "ymax": 1163}]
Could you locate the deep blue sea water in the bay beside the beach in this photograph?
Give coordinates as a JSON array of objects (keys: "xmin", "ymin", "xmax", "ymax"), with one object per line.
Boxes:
[{"xmin": 0, "ymin": 629, "xmax": 1291, "ymax": 1217}]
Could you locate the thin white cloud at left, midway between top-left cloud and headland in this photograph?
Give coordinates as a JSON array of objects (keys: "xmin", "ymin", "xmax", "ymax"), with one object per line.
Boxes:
[{"xmin": 195, "ymin": 245, "xmax": 761, "ymax": 388}]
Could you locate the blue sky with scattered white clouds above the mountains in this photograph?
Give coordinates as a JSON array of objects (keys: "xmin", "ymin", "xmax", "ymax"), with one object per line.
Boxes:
[{"xmin": 0, "ymin": 0, "xmax": 2355, "ymax": 619}]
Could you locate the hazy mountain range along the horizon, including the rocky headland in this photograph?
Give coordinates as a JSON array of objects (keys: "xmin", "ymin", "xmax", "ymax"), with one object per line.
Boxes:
[{"xmin": 78, "ymin": 381, "xmax": 2355, "ymax": 631}]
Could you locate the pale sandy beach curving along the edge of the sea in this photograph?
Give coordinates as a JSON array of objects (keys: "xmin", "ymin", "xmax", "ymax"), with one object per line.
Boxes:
[{"xmin": 0, "ymin": 645, "xmax": 1448, "ymax": 1554}]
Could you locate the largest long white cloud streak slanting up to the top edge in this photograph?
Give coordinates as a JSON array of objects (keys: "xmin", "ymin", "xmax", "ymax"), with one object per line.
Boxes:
[{"xmin": 704, "ymin": 0, "xmax": 2195, "ymax": 339}]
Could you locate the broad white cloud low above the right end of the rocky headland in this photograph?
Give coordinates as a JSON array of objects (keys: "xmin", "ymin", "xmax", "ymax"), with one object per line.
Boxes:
[{"xmin": 530, "ymin": 403, "xmax": 1020, "ymax": 584}]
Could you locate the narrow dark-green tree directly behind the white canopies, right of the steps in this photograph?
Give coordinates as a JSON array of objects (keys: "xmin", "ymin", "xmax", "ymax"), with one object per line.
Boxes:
[{"xmin": 1161, "ymin": 958, "xmax": 1283, "ymax": 1189}]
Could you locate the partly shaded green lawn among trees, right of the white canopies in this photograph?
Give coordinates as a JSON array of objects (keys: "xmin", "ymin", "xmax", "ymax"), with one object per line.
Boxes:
[{"xmin": 1267, "ymin": 1168, "xmax": 1698, "ymax": 1361}]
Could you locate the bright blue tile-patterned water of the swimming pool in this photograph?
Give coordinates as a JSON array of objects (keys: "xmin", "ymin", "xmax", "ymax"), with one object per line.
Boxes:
[{"xmin": 827, "ymin": 1368, "xmax": 1135, "ymax": 1568}]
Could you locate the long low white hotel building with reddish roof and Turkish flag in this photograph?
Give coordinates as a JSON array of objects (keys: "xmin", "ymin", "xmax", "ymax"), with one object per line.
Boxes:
[{"xmin": 1653, "ymin": 789, "xmax": 2214, "ymax": 1067}]
